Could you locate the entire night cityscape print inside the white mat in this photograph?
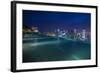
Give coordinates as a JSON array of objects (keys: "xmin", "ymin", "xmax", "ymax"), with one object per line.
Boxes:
[{"xmin": 22, "ymin": 10, "xmax": 91, "ymax": 63}]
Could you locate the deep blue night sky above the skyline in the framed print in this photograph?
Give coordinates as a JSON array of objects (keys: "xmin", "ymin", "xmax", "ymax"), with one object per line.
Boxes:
[{"xmin": 23, "ymin": 10, "xmax": 91, "ymax": 32}]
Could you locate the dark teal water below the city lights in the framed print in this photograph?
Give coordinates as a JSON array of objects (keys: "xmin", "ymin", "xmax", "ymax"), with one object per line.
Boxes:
[{"xmin": 23, "ymin": 34, "xmax": 91, "ymax": 63}]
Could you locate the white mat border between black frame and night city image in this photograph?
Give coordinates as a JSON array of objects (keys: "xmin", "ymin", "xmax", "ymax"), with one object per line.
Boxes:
[{"xmin": 16, "ymin": 4, "xmax": 96, "ymax": 70}]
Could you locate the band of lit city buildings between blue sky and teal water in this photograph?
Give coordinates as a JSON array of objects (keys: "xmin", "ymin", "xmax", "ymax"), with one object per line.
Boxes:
[{"xmin": 23, "ymin": 26, "xmax": 90, "ymax": 41}]
